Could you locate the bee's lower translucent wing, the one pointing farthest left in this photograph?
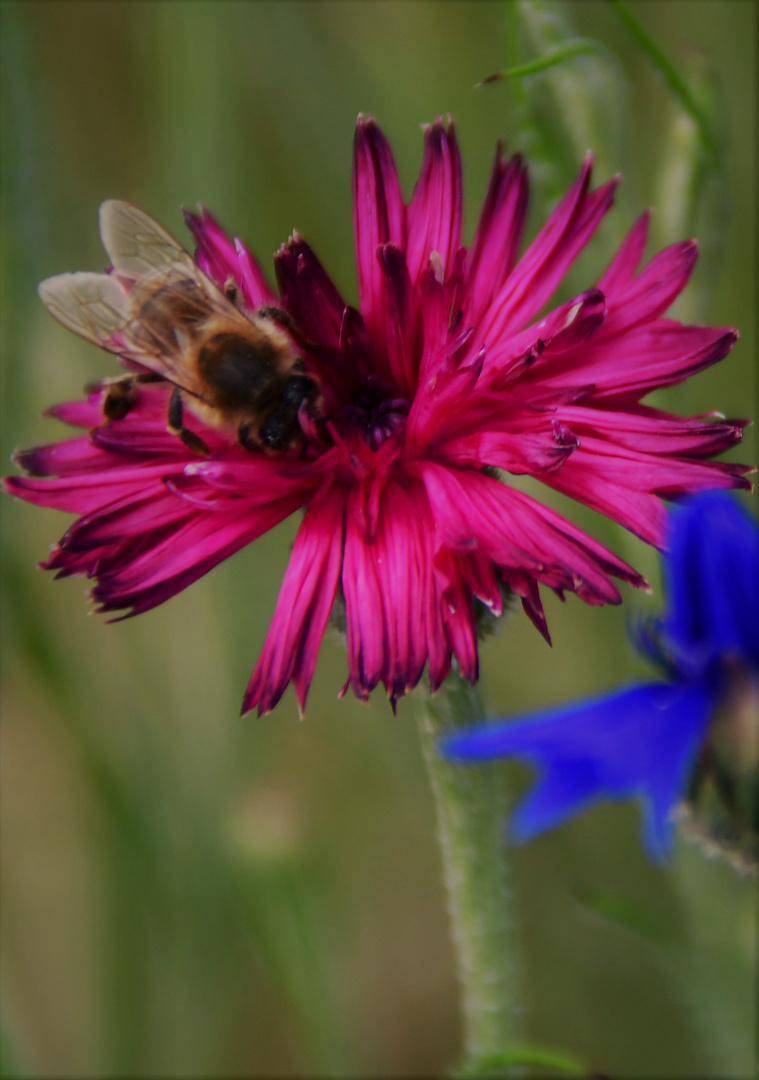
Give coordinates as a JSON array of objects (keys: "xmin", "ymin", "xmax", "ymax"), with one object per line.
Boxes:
[{"xmin": 39, "ymin": 271, "xmax": 130, "ymax": 346}]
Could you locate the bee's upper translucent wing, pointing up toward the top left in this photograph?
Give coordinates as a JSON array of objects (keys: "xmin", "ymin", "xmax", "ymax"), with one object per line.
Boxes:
[{"xmin": 100, "ymin": 199, "xmax": 196, "ymax": 278}]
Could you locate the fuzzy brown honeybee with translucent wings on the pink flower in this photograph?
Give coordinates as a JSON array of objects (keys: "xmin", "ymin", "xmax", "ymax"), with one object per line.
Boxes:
[{"xmin": 39, "ymin": 200, "xmax": 323, "ymax": 454}]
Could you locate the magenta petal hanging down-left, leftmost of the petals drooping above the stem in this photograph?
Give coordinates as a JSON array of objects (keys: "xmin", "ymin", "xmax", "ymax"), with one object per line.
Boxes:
[{"xmin": 243, "ymin": 490, "xmax": 345, "ymax": 716}]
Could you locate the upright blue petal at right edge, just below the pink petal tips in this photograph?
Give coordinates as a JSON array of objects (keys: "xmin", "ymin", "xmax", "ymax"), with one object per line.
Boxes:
[{"xmin": 663, "ymin": 491, "xmax": 759, "ymax": 674}]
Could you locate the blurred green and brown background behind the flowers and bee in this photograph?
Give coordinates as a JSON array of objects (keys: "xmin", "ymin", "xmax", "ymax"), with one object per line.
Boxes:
[{"xmin": 0, "ymin": 0, "xmax": 757, "ymax": 1078}]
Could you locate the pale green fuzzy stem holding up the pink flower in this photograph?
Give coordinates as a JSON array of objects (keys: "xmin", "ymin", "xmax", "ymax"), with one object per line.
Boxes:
[{"xmin": 420, "ymin": 672, "xmax": 517, "ymax": 1074}]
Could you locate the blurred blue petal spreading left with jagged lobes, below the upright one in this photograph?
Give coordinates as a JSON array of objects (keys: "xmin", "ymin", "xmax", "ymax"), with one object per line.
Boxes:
[{"xmin": 441, "ymin": 683, "xmax": 715, "ymax": 859}]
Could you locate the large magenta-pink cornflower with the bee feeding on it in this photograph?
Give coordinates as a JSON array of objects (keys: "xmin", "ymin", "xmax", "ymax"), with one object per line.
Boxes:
[{"xmin": 5, "ymin": 118, "xmax": 750, "ymax": 713}]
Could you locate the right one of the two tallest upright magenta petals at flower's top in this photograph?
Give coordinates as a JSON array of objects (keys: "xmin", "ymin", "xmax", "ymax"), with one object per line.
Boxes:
[{"xmin": 406, "ymin": 119, "xmax": 462, "ymax": 284}]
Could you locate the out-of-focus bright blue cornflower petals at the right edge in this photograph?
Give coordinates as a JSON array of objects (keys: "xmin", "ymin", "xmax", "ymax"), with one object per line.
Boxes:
[{"xmin": 442, "ymin": 491, "xmax": 759, "ymax": 859}]
